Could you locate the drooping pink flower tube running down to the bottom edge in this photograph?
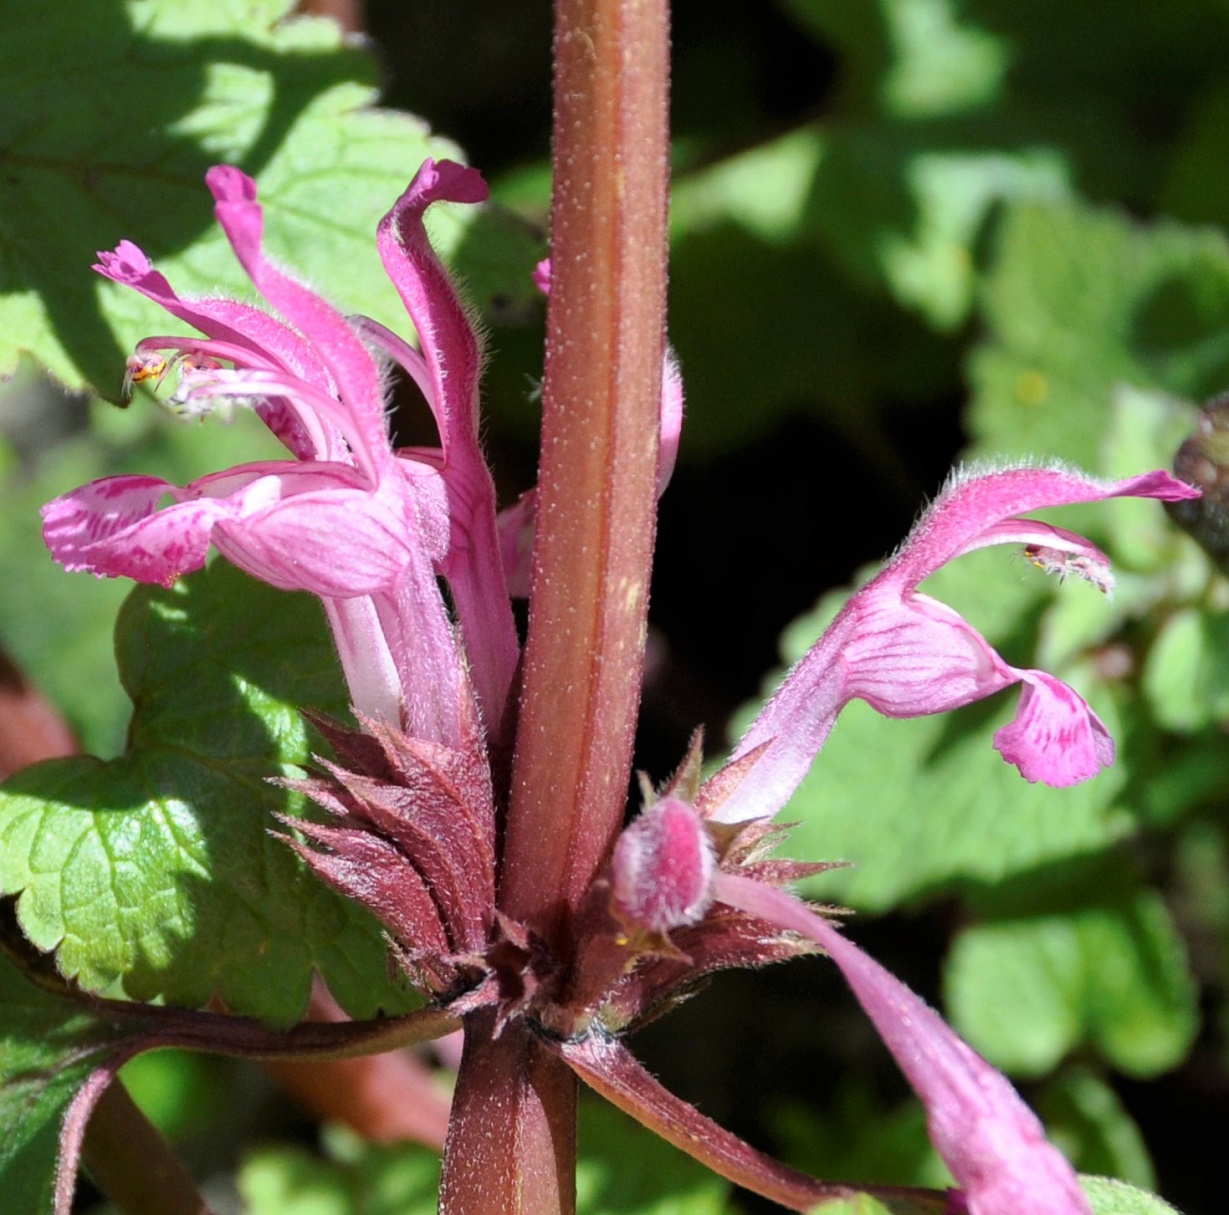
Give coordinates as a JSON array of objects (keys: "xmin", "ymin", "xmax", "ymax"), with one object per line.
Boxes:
[{"xmin": 715, "ymin": 873, "xmax": 1091, "ymax": 1215}]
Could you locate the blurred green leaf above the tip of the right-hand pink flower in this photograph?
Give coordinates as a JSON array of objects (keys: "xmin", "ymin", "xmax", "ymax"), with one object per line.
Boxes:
[{"xmin": 968, "ymin": 204, "xmax": 1229, "ymax": 468}]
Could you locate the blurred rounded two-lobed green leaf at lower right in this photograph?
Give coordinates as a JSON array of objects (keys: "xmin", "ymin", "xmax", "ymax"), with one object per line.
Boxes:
[{"xmin": 945, "ymin": 891, "xmax": 1198, "ymax": 1076}]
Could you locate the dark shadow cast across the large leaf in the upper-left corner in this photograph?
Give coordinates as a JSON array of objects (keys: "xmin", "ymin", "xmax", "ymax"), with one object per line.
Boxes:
[{"xmin": 0, "ymin": 0, "xmax": 385, "ymax": 392}]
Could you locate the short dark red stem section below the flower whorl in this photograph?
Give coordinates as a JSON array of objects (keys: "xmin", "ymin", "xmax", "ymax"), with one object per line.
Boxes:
[{"xmin": 440, "ymin": 1011, "xmax": 576, "ymax": 1215}]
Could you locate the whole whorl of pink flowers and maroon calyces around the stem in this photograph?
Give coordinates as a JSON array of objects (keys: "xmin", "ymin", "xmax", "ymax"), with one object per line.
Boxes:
[{"xmin": 43, "ymin": 161, "xmax": 1196, "ymax": 1215}]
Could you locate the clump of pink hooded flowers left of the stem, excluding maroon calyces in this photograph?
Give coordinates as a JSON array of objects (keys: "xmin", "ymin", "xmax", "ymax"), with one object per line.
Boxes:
[{"xmin": 43, "ymin": 161, "xmax": 517, "ymax": 744}]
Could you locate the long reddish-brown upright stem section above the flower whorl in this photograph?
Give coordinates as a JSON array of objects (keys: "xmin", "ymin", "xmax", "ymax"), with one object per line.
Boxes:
[{"xmin": 500, "ymin": 0, "xmax": 669, "ymax": 946}]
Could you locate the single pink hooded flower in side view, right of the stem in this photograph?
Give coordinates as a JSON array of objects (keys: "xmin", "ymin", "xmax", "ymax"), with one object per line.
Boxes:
[{"xmin": 713, "ymin": 468, "xmax": 1198, "ymax": 822}]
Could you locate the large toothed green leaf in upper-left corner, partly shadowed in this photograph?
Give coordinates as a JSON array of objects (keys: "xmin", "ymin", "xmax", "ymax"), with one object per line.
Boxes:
[{"xmin": 0, "ymin": 0, "xmax": 465, "ymax": 391}]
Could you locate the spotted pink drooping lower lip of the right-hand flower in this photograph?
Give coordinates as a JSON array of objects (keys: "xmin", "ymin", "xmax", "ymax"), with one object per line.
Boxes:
[{"xmin": 994, "ymin": 671, "xmax": 1113, "ymax": 787}]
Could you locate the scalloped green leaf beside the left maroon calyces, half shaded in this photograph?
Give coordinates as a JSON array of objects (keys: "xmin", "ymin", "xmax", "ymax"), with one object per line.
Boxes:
[{"xmin": 0, "ymin": 561, "xmax": 417, "ymax": 1025}]
